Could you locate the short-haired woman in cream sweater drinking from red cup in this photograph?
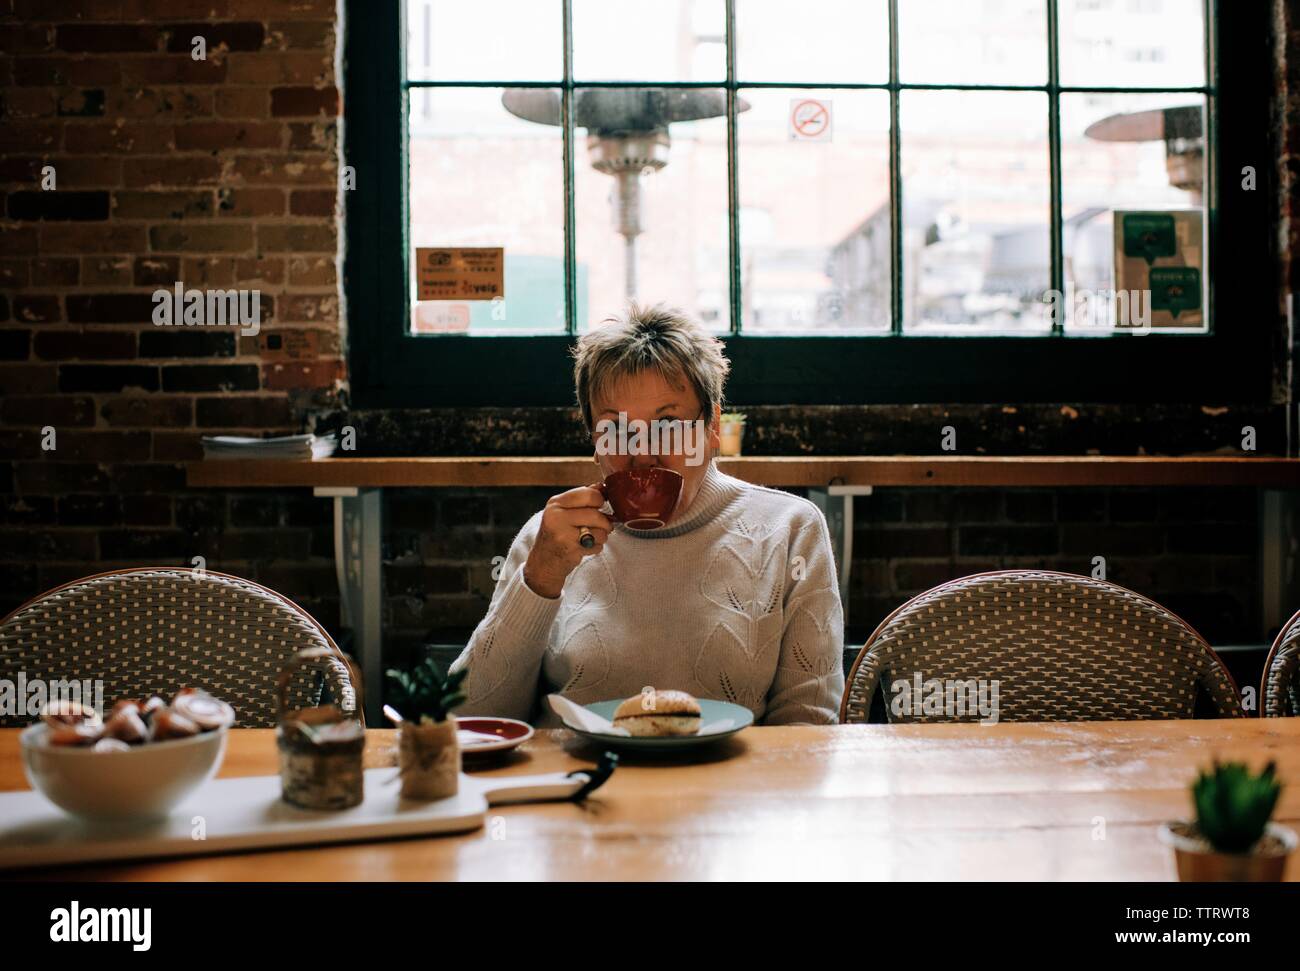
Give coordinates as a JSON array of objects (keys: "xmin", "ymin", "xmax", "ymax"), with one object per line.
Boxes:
[{"xmin": 451, "ymin": 304, "xmax": 844, "ymax": 727}]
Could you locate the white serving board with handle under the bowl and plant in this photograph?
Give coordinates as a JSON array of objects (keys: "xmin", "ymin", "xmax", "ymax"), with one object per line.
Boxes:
[{"xmin": 0, "ymin": 767, "xmax": 588, "ymax": 870}]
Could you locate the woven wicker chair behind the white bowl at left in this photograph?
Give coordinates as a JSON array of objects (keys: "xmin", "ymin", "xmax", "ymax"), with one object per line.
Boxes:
[{"xmin": 0, "ymin": 567, "xmax": 359, "ymax": 728}]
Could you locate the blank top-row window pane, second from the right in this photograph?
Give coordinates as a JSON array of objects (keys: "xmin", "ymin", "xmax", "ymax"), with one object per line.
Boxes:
[{"xmin": 898, "ymin": 0, "xmax": 1048, "ymax": 84}]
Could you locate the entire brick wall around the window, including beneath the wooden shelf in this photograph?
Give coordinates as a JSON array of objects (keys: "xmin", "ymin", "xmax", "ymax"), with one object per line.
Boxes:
[{"xmin": 0, "ymin": 0, "xmax": 1300, "ymax": 681}]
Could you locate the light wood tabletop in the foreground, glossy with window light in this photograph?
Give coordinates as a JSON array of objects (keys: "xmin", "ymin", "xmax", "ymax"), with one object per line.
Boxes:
[{"xmin": 0, "ymin": 719, "xmax": 1300, "ymax": 881}]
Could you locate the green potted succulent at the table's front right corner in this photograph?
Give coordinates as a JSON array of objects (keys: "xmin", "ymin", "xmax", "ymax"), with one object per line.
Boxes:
[{"xmin": 1160, "ymin": 762, "xmax": 1296, "ymax": 881}]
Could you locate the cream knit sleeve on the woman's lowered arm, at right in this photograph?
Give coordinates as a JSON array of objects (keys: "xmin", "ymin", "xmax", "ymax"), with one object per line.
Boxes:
[{"xmin": 763, "ymin": 503, "xmax": 844, "ymax": 725}]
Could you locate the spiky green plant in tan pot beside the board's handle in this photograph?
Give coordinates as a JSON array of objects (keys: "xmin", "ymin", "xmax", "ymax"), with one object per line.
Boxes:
[{"xmin": 387, "ymin": 658, "xmax": 468, "ymax": 799}]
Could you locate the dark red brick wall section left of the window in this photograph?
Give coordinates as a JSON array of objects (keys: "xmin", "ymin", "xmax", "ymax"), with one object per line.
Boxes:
[{"xmin": 0, "ymin": 0, "xmax": 345, "ymax": 621}]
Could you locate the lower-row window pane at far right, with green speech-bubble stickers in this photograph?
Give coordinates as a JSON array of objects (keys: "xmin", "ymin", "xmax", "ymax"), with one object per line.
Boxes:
[{"xmin": 1061, "ymin": 94, "xmax": 1206, "ymax": 335}]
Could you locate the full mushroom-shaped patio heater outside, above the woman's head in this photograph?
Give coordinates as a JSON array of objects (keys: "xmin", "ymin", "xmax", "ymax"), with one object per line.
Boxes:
[{"xmin": 501, "ymin": 87, "xmax": 749, "ymax": 299}]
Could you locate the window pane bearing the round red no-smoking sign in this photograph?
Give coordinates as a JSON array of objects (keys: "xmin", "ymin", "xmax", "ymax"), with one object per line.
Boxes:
[{"xmin": 737, "ymin": 88, "xmax": 892, "ymax": 334}]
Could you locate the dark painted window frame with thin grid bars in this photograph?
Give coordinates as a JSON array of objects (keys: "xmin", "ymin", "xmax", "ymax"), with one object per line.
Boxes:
[{"xmin": 342, "ymin": 0, "xmax": 1279, "ymax": 408}]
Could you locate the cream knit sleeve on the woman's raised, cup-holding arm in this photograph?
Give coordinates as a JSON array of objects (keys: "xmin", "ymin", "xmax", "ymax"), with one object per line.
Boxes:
[{"xmin": 450, "ymin": 512, "xmax": 560, "ymax": 721}]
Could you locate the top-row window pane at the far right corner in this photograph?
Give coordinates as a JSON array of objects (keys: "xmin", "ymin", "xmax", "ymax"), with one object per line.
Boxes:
[{"xmin": 1060, "ymin": 0, "xmax": 1205, "ymax": 87}]
